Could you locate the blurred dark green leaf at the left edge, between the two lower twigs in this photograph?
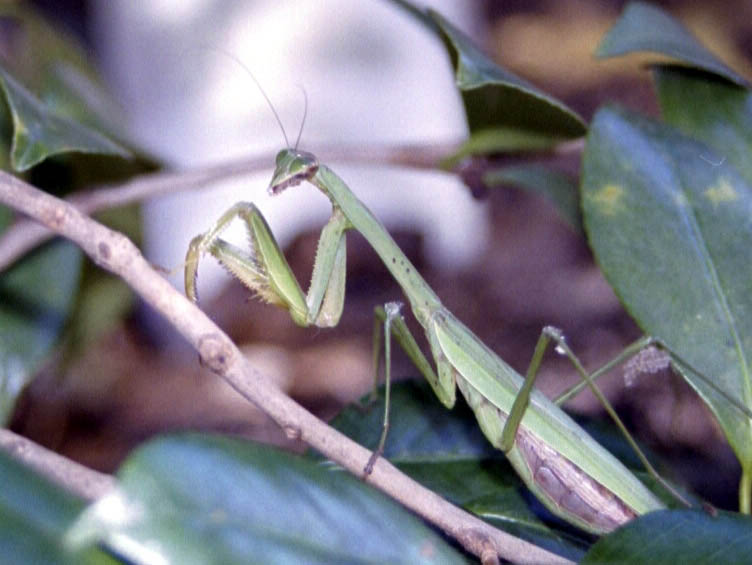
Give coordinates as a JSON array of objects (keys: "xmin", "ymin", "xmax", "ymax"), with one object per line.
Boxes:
[{"xmin": 0, "ymin": 216, "xmax": 83, "ymax": 425}]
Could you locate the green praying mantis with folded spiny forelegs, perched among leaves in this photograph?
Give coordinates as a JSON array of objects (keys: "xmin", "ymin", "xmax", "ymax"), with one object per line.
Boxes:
[{"xmin": 185, "ymin": 144, "xmax": 664, "ymax": 534}]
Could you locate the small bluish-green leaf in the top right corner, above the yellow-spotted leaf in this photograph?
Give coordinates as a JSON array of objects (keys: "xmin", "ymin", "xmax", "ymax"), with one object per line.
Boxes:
[{"xmin": 595, "ymin": 2, "xmax": 747, "ymax": 85}]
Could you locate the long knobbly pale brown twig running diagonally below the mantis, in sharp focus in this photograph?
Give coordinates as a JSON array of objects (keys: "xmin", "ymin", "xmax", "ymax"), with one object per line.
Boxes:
[{"xmin": 0, "ymin": 172, "xmax": 568, "ymax": 563}]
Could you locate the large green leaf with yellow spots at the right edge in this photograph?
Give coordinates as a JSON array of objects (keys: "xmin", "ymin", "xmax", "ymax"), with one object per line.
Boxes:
[{"xmin": 582, "ymin": 108, "xmax": 752, "ymax": 473}]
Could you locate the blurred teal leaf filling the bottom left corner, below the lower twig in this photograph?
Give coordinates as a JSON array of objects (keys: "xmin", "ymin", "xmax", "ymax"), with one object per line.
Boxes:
[{"xmin": 0, "ymin": 452, "xmax": 115, "ymax": 565}]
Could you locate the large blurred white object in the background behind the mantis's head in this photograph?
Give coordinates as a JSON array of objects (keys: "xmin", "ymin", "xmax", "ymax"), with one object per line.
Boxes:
[{"xmin": 92, "ymin": 0, "xmax": 488, "ymax": 299}]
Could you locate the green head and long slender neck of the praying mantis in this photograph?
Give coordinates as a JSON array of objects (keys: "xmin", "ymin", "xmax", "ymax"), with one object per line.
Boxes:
[{"xmin": 269, "ymin": 149, "xmax": 442, "ymax": 327}]
